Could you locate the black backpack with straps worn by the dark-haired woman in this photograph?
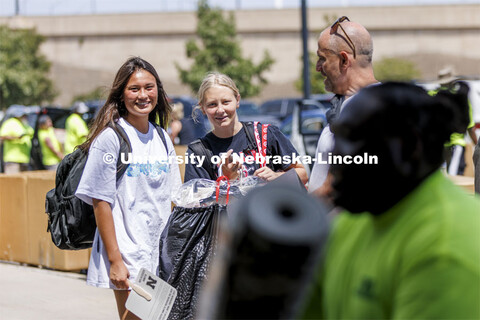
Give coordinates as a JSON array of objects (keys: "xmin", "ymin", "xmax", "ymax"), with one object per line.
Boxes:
[{"xmin": 45, "ymin": 125, "xmax": 168, "ymax": 250}]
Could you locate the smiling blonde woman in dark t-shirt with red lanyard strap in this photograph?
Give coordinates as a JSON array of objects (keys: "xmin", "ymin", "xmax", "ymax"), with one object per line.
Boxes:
[{"xmin": 185, "ymin": 72, "xmax": 308, "ymax": 183}]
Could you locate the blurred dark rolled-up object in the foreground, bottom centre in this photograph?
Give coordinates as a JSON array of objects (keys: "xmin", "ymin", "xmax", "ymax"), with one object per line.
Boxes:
[{"xmin": 197, "ymin": 183, "xmax": 328, "ymax": 319}]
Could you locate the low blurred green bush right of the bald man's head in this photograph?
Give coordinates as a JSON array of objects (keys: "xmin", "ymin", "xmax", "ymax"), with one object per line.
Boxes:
[{"xmin": 373, "ymin": 58, "xmax": 421, "ymax": 82}]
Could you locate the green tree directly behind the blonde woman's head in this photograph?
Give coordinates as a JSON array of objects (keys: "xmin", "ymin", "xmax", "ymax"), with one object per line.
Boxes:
[{"xmin": 175, "ymin": 0, "xmax": 274, "ymax": 98}]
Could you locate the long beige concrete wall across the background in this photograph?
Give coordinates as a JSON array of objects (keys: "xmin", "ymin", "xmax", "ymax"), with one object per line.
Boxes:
[{"xmin": 0, "ymin": 4, "xmax": 480, "ymax": 104}]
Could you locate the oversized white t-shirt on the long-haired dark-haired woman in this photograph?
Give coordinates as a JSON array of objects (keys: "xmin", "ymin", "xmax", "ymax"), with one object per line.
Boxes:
[{"xmin": 75, "ymin": 118, "xmax": 181, "ymax": 289}]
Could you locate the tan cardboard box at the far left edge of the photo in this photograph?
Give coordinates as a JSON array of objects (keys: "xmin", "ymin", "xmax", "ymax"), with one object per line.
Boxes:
[{"xmin": 0, "ymin": 174, "xmax": 30, "ymax": 262}]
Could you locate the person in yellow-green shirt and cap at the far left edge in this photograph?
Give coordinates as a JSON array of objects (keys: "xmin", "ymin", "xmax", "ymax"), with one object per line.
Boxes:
[{"xmin": 0, "ymin": 106, "xmax": 33, "ymax": 173}]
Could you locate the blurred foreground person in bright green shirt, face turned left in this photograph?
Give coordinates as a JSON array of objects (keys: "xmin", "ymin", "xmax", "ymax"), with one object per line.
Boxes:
[{"xmin": 301, "ymin": 83, "xmax": 480, "ymax": 319}]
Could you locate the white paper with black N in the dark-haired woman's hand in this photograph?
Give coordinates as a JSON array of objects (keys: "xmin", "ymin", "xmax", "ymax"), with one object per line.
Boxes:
[{"xmin": 125, "ymin": 268, "xmax": 177, "ymax": 320}]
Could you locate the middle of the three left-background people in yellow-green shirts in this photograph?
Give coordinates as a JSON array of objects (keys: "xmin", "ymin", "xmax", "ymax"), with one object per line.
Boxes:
[{"xmin": 38, "ymin": 115, "xmax": 63, "ymax": 170}]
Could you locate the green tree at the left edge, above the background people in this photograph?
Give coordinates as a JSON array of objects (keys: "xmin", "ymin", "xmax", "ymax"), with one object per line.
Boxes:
[{"xmin": 0, "ymin": 26, "xmax": 57, "ymax": 109}]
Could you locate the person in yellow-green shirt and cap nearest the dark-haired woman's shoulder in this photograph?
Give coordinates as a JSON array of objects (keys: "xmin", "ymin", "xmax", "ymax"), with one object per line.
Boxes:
[{"xmin": 64, "ymin": 102, "xmax": 88, "ymax": 155}]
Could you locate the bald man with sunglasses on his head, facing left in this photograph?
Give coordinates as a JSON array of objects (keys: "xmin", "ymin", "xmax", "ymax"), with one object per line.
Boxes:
[{"xmin": 308, "ymin": 16, "xmax": 378, "ymax": 198}]
